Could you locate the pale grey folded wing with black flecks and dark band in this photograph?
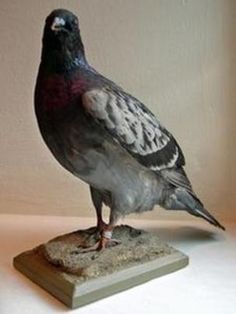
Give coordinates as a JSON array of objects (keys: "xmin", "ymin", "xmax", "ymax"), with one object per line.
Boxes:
[{"xmin": 82, "ymin": 87, "xmax": 185, "ymax": 171}]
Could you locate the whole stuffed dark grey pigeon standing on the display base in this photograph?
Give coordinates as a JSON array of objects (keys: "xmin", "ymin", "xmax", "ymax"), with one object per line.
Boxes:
[{"xmin": 35, "ymin": 9, "xmax": 224, "ymax": 250}]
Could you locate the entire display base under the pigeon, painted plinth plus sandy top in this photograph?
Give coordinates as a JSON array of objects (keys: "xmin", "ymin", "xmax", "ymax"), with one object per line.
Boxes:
[{"xmin": 13, "ymin": 225, "xmax": 188, "ymax": 308}]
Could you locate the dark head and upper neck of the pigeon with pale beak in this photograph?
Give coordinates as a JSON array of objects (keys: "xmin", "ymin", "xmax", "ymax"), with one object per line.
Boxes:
[{"xmin": 42, "ymin": 9, "xmax": 86, "ymax": 72}]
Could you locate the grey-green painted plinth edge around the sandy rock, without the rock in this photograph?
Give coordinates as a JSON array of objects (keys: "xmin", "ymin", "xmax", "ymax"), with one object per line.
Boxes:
[{"xmin": 13, "ymin": 226, "xmax": 188, "ymax": 308}]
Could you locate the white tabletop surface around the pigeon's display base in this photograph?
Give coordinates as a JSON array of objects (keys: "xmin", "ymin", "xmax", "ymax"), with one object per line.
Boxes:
[{"xmin": 0, "ymin": 215, "xmax": 236, "ymax": 314}]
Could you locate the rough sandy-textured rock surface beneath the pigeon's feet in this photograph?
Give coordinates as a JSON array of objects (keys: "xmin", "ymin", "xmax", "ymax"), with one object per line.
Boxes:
[{"xmin": 40, "ymin": 225, "xmax": 174, "ymax": 281}]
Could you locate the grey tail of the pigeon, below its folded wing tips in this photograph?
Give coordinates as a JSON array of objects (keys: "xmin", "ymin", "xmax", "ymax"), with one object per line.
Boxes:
[{"xmin": 164, "ymin": 188, "xmax": 225, "ymax": 230}]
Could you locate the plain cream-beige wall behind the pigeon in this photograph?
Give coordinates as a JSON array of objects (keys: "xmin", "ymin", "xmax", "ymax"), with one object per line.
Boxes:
[{"xmin": 0, "ymin": 0, "xmax": 236, "ymax": 219}]
